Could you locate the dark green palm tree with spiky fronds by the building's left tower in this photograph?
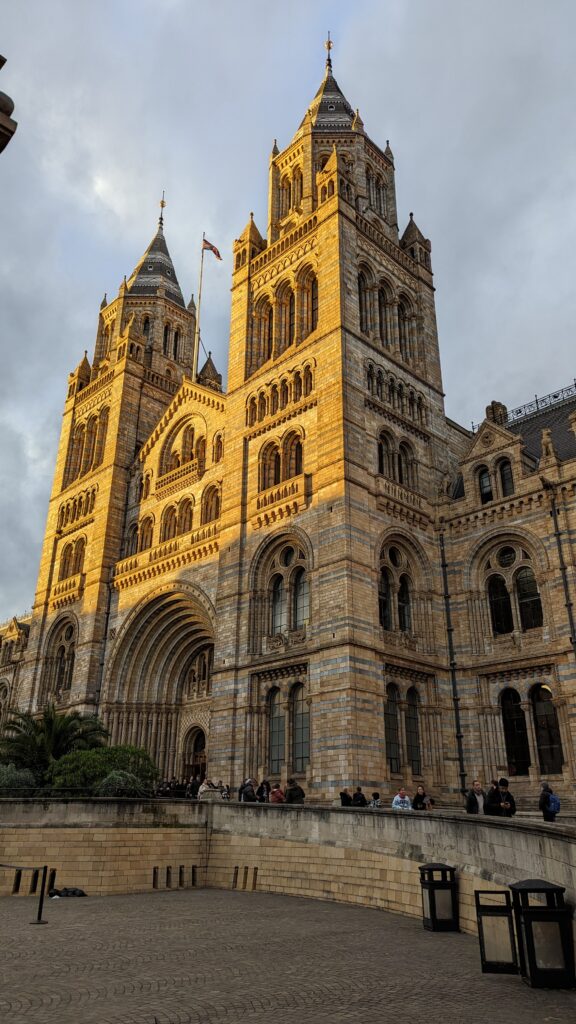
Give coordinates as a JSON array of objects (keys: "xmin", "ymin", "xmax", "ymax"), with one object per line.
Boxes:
[{"xmin": 0, "ymin": 703, "xmax": 109, "ymax": 781}]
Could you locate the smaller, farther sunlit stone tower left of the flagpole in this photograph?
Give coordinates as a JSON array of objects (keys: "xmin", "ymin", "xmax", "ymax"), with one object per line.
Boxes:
[{"xmin": 17, "ymin": 204, "xmax": 196, "ymax": 710}]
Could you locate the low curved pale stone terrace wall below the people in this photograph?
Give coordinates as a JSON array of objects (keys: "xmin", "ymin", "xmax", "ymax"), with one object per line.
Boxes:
[{"xmin": 0, "ymin": 800, "xmax": 576, "ymax": 932}]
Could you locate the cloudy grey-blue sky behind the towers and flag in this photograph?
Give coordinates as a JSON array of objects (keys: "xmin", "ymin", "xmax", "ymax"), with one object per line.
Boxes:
[{"xmin": 0, "ymin": 0, "xmax": 576, "ymax": 621}]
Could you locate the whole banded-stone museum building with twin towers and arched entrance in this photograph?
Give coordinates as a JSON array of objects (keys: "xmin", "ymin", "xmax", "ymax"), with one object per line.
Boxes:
[{"xmin": 0, "ymin": 61, "xmax": 576, "ymax": 800}]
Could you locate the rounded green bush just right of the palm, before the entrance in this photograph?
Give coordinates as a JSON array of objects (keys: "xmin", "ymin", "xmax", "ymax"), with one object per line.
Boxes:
[{"xmin": 49, "ymin": 746, "xmax": 158, "ymax": 796}]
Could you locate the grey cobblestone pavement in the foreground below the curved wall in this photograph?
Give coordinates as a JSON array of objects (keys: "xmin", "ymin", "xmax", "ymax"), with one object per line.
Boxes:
[{"xmin": 0, "ymin": 890, "xmax": 576, "ymax": 1024}]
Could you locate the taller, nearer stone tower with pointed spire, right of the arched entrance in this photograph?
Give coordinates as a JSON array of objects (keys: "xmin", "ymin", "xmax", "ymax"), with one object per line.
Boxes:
[{"xmin": 210, "ymin": 43, "xmax": 450, "ymax": 793}]
